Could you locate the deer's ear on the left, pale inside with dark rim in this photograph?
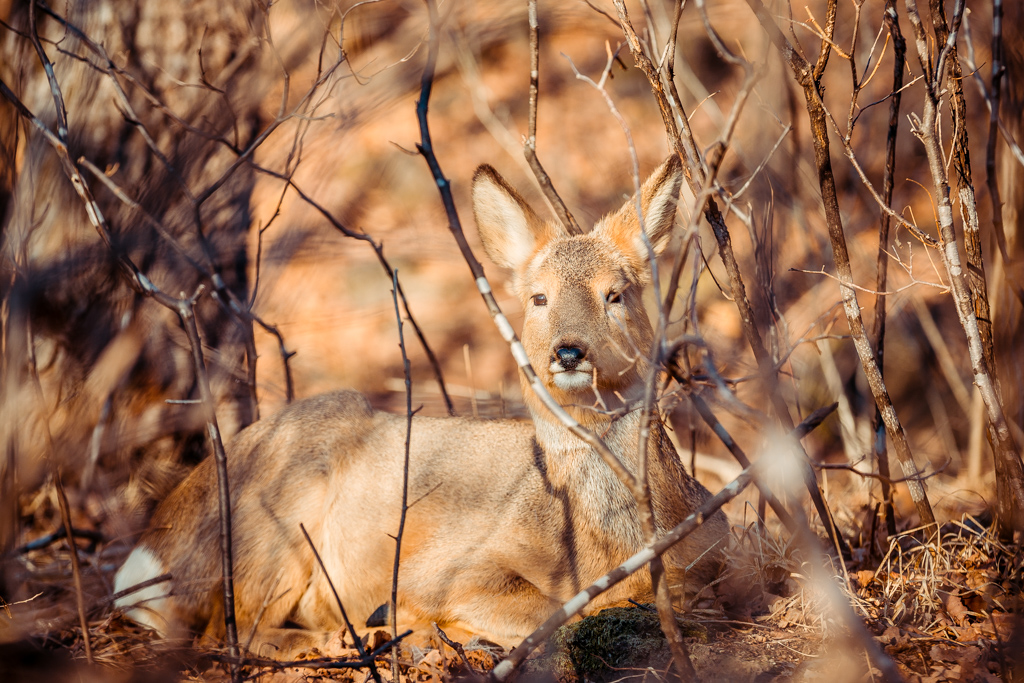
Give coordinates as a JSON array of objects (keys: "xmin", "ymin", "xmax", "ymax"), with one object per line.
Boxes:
[{"xmin": 473, "ymin": 164, "xmax": 555, "ymax": 271}]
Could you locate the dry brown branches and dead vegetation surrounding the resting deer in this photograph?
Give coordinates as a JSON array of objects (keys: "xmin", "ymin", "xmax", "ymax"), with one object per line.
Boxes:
[{"xmin": 0, "ymin": 0, "xmax": 1024, "ymax": 682}]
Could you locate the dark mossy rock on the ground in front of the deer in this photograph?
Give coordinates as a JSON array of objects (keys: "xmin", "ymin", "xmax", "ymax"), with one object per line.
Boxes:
[{"xmin": 520, "ymin": 605, "xmax": 707, "ymax": 683}]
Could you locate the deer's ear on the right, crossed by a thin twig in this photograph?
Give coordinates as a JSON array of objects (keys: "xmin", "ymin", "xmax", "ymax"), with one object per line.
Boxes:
[{"xmin": 595, "ymin": 155, "xmax": 683, "ymax": 270}]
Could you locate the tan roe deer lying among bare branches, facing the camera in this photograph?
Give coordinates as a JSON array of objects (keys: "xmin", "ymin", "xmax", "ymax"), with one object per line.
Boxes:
[{"xmin": 115, "ymin": 157, "xmax": 728, "ymax": 657}]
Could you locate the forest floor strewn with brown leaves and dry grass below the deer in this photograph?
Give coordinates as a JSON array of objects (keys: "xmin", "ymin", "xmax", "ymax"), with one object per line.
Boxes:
[{"xmin": 0, "ymin": 493, "xmax": 1024, "ymax": 683}]
